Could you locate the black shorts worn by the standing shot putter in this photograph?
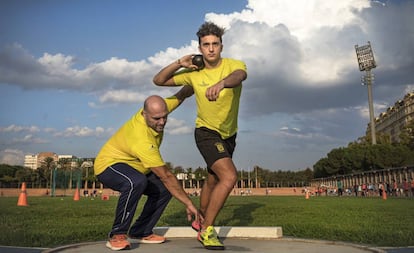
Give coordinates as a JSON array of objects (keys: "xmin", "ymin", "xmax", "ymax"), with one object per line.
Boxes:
[{"xmin": 194, "ymin": 127, "xmax": 237, "ymax": 173}]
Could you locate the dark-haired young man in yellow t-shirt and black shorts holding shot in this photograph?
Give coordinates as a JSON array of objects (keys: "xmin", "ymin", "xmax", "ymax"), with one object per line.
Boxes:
[{"xmin": 154, "ymin": 22, "xmax": 247, "ymax": 249}]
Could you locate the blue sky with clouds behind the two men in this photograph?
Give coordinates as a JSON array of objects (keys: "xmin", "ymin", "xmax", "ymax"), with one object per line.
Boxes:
[{"xmin": 0, "ymin": 0, "xmax": 414, "ymax": 171}]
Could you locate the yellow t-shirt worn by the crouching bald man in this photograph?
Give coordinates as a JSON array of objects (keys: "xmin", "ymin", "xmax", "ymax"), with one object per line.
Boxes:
[{"xmin": 94, "ymin": 96, "xmax": 180, "ymax": 175}]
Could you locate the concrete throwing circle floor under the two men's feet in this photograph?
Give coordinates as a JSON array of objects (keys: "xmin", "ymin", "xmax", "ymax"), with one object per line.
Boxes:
[{"xmin": 43, "ymin": 238, "xmax": 385, "ymax": 253}]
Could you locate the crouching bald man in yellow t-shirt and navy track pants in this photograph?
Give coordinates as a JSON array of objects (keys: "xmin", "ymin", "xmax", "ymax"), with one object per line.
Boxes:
[{"xmin": 94, "ymin": 87, "xmax": 200, "ymax": 250}]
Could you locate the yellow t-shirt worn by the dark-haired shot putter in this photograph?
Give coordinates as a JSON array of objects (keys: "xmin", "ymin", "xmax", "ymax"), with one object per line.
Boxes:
[{"xmin": 174, "ymin": 58, "xmax": 246, "ymax": 139}]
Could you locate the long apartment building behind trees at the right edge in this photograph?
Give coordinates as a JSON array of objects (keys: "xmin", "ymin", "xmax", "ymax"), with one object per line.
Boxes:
[{"xmin": 366, "ymin": 92, "xmax": 414, "ymax": 143}]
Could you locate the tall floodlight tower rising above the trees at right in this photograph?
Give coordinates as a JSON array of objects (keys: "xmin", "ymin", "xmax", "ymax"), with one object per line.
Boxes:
[{"xmin": 355, "ymin": 41, "xmax": 377, "ymax": 145}]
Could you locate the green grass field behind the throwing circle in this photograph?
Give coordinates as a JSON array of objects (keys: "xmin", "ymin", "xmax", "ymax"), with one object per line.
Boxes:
[{"xmin": 0, "ymin": 196, "xmax": 414, "ymax": 247}]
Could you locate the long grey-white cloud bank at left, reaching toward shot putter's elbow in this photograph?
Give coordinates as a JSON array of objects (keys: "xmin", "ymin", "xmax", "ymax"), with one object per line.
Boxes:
[{"xmin": 0, "ymin": 44, "xmax": 155, "ymax": 91}]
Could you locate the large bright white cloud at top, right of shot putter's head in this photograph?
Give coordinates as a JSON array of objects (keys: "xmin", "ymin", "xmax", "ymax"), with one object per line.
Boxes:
[{"xmin": 206, "ymin": 0, "xmax": 370, "ymax": 83}]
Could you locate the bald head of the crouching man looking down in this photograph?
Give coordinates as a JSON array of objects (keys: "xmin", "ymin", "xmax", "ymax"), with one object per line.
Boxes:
[{"xmin": 142, "ymin": 95, "xmax": 168, "ymax": 133}]
